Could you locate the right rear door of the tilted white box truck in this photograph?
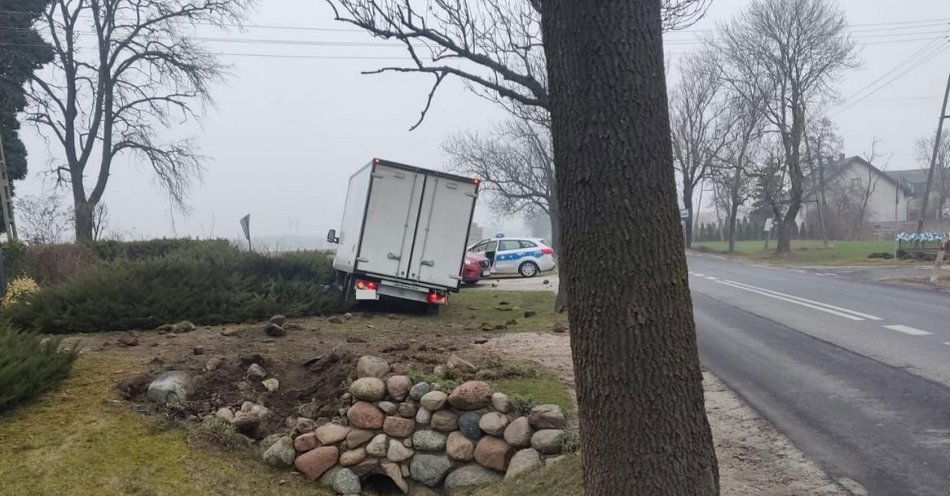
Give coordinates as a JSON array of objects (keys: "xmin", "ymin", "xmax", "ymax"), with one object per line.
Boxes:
[{"xmin": 409, "ymin": 175, "xmax": 478, "ymax": 288}]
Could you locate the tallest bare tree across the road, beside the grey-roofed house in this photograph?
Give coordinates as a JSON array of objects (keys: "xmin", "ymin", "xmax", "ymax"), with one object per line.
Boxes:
[{"xmin": 716, "ymin": 0, "xmax": 856, "ymax": 253}]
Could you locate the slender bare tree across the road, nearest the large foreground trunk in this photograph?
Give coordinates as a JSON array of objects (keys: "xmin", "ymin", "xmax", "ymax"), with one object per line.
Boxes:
[{"xmin": 670, "ymin": 53, "xmax": 728, "ymax": 247}]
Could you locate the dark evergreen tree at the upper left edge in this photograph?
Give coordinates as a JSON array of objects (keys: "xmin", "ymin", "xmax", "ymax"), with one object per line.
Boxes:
[{"xmin": 0, "ymin": 0, "xmax": 53, "ymax": 181}]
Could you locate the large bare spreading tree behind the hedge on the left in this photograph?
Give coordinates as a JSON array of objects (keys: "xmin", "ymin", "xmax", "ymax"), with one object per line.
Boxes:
[{"xmin": 27, "ymin": 0, "xmax": 253, "ymax": 242}]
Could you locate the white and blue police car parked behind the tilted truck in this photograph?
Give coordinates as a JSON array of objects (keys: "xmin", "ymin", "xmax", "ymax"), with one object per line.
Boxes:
[{"xmin": 468, "ymin": 237, "xmax": 556, "ymax": 277}]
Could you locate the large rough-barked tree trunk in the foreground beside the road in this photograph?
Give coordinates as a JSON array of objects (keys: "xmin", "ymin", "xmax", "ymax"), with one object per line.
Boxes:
[{"xmin": 539, "ymin": 0, "xmax": 719, "ymax": 496}]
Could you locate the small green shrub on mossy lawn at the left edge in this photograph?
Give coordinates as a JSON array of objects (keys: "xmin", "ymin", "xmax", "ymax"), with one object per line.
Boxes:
[{"xmin": 0, "ymin": 327, "xmax": 77, "ymax": 413}]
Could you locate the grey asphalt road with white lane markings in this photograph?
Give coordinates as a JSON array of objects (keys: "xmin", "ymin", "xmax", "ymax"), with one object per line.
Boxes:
[{"xmin": 689, "ymin": 255, "xmax": 950, "ymax": 496}]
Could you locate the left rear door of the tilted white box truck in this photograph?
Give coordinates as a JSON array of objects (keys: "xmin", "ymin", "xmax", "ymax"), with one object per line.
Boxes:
[{"xmin": 357, "ymin": 164, "xmax": 425, "ymax": 278}]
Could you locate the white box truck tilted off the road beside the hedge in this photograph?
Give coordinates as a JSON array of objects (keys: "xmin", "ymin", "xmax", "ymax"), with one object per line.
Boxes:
[{"xmin": 327, "ymin": 159, "xmax": 479, "ymax": 308}]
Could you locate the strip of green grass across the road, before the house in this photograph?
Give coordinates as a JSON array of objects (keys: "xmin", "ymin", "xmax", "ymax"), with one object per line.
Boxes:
[{"xmin": 693, "ymin": 240, "xmax": 906, "ymax": 265}]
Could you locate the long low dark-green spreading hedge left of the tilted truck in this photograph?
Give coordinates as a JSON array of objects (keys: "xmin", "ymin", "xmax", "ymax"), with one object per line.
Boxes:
[{"xmin": 9, "ymin": 242, "xmax": 338, "ymax": 334}]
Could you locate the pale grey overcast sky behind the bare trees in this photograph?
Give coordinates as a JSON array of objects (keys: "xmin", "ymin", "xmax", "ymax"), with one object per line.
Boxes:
[{"xmin": 18, "ymin": 0, "xmax": 950, "ymax": 238}]
